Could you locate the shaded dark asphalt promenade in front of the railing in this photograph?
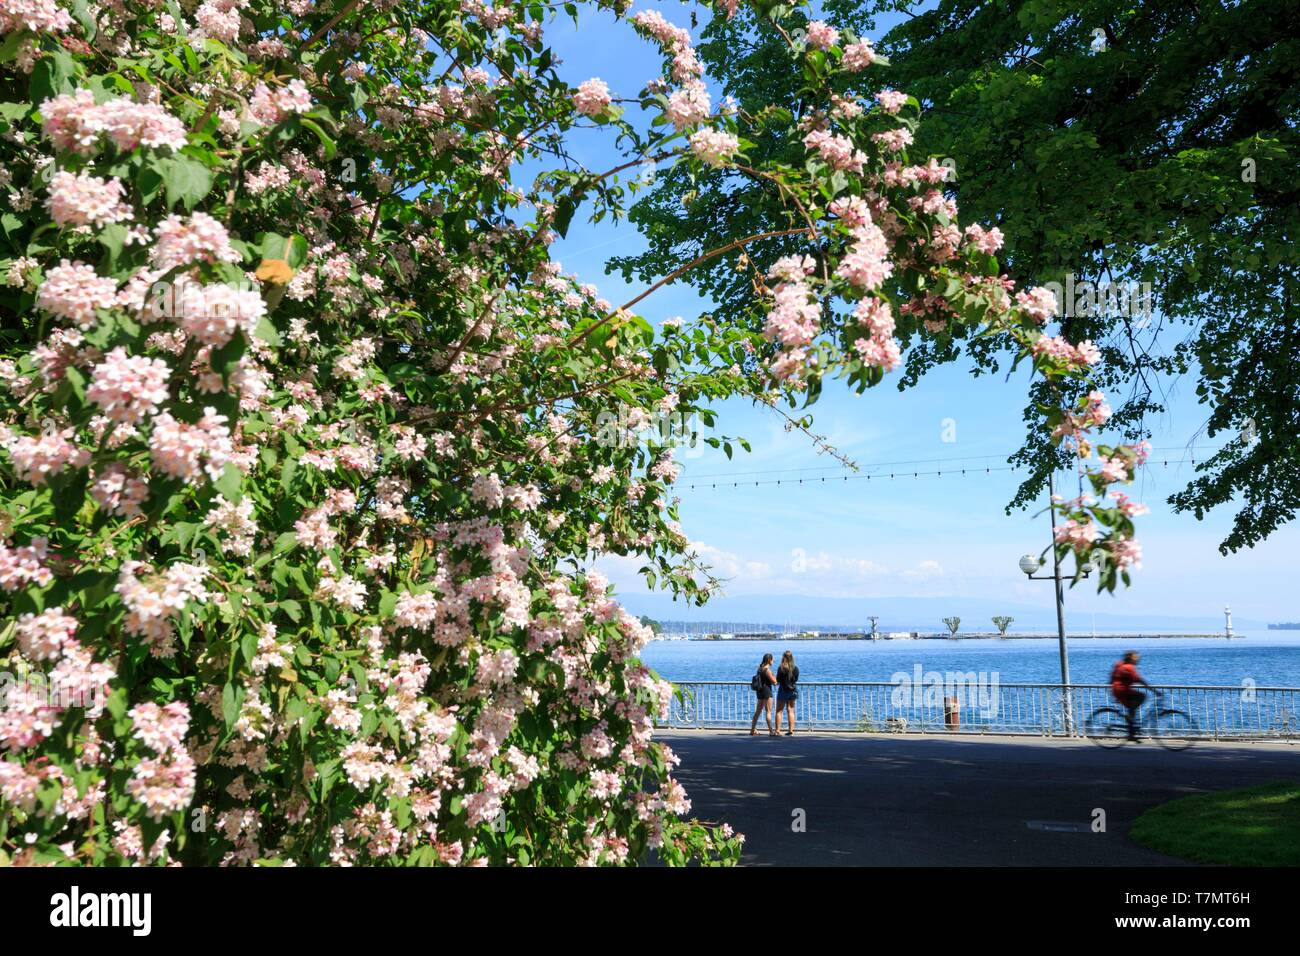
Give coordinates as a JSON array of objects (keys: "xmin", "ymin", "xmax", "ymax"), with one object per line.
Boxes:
[{"xmin": 655, "ymin": 730, "xmax": 1300, "ymax": 866}]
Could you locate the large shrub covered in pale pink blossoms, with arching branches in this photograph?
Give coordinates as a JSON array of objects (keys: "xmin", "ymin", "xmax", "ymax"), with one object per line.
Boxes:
[{"xmin": 0, "ymin": 0, "xmax": 1138, "ymax": 865}]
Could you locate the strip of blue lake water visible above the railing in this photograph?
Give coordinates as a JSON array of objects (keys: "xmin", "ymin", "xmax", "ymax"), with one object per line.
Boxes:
[{"xmin": 641, "ymin": 631, "xmax": 1300, "ymax": 687}]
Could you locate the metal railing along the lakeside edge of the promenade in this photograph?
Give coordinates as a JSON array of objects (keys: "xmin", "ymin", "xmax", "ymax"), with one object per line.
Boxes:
[{"xmin": 659, "ymin": 674, "xmax": 1300, "ymax": 740}]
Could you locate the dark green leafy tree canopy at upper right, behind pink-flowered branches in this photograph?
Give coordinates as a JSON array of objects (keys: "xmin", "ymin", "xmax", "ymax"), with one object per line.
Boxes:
[{"xmin": 615, "ymin": 0, "xmax": 1300, "ymax": 550}]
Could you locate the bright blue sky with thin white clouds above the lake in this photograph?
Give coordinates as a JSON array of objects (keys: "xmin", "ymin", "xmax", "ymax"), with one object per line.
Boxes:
[{"xmin": 533, "ymin": 3, "xmax": 1300, "ymax": 620}]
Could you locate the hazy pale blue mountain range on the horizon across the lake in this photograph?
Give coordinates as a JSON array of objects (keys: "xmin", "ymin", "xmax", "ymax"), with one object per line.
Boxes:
[{"xmin": 620, "ymin": 594, "xmax": 1265, "ymax": 633}]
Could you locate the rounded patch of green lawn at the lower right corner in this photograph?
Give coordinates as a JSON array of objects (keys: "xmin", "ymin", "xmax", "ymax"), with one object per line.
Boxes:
[{"xmin": 1128, "ymin": 780, "xmax": 1300, "ymax": 866}]
